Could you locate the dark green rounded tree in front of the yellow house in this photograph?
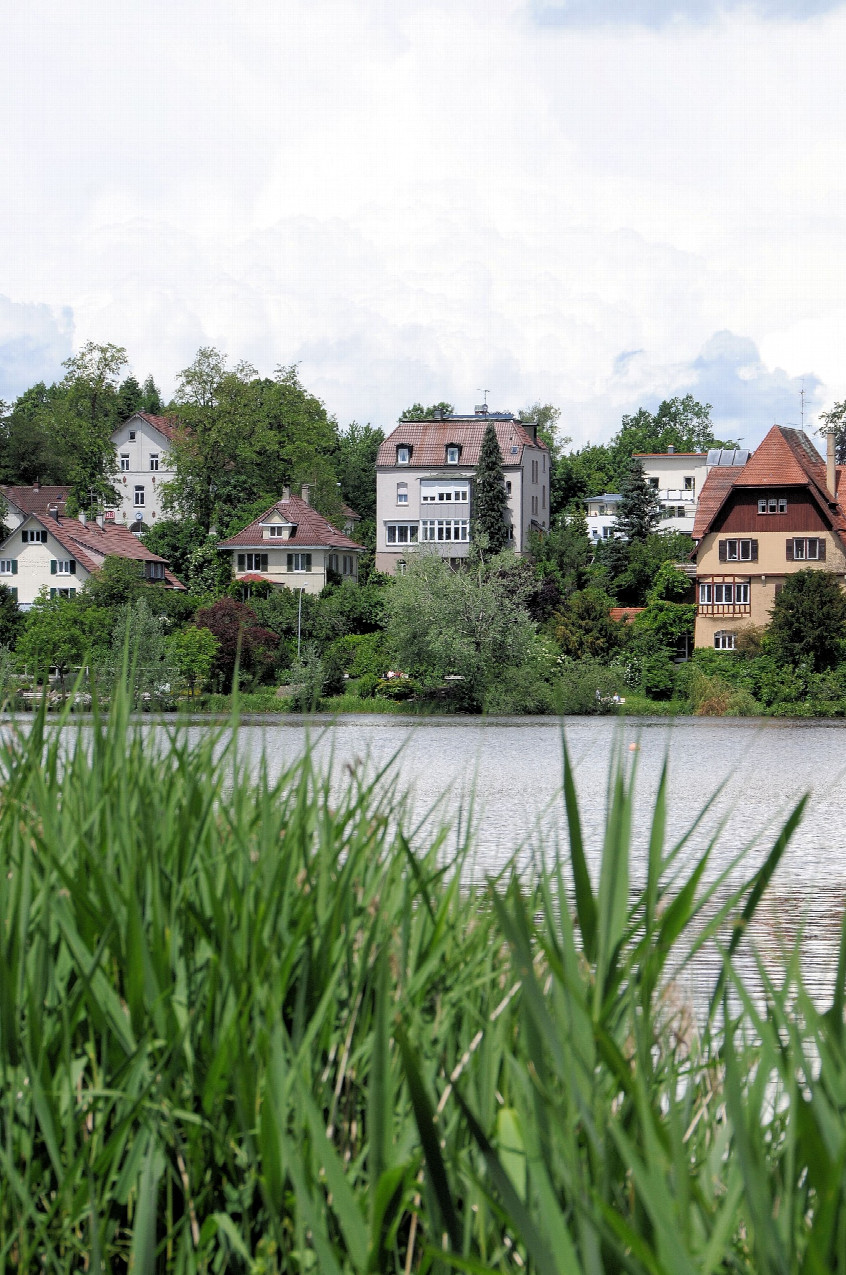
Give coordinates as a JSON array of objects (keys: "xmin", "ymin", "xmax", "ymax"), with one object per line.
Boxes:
[{"xmin": 766, "ymin": 567, "xmax": 846, "ymax": 672}]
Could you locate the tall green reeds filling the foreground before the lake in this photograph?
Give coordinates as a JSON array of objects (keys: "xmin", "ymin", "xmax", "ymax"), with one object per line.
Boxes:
[{"xmin": 0, "ymin": 686, "xmax": 846, "ymax": 1275}]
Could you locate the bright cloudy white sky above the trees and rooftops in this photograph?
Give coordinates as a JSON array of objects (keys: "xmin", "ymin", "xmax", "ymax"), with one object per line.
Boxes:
[{"xmin": 0, "ymin": 0, "xmax": 846, "ymax": 446}]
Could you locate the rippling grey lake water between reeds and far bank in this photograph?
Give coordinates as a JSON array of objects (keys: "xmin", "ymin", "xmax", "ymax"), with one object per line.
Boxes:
[{"xmin": 16, "ymin": 717, "xmax": 846, "ymax": 996}]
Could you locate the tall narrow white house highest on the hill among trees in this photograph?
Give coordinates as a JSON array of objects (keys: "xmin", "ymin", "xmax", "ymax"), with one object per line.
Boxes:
[{"xmin": 106, "ymin": 412, "xmax": 177, "ymax": 529}]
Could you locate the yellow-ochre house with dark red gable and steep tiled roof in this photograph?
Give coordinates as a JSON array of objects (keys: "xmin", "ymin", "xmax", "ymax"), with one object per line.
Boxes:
[{"xmin": 693, "ymin": 425, "xmax": 846, "ymax": 650}]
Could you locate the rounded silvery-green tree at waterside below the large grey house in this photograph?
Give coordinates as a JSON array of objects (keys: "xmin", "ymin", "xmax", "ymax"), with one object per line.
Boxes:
[{"xmin": 385, "ymin": 552, "xmax": 535, "ymax": 708}]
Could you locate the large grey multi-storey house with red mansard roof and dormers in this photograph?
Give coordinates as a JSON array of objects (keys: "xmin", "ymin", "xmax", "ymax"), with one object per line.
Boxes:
[{"xmin": 376, "ymin": 407, "xmax": 549, "ymax": 575}]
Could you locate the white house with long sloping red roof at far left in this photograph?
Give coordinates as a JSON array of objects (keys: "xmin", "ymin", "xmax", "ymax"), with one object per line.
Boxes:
[{"xmin": 0, "ymin": 506, "xmax": 182, "ymax": 611}]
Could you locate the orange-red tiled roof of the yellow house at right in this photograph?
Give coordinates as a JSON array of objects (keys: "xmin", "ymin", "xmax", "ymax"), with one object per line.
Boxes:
[{"xmin": 693, "ymin": 425, "xmax": 846, "ymax": 544}]
